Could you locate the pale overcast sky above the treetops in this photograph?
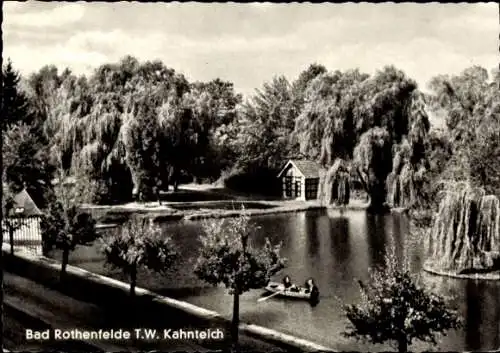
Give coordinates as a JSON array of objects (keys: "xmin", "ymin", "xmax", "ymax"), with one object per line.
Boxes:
[{"xmin": 3, "ymin": 2, "xmax": 500, "ymax": 94}]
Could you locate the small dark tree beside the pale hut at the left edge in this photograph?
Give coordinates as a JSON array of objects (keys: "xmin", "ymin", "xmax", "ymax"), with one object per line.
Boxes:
[{"xmin": 41, "ymin": 152, "xmax": 97, "ymax": 280}]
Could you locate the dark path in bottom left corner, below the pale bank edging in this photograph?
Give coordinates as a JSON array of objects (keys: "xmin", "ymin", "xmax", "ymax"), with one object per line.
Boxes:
[{"xmin": 4, "ymin": 273, "xmax": 286, "ymax": 352}]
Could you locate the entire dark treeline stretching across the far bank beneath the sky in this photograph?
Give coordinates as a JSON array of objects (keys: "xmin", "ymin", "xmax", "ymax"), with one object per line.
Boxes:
[{"xmin": 2, "ymin": 56, "xmax": 500, "ymax": 209}]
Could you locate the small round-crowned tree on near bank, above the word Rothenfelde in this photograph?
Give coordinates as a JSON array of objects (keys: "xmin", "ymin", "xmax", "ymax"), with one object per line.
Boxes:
[{"xmin": 103, "ymin": 216, "xmax": 177, "ymax": 297}]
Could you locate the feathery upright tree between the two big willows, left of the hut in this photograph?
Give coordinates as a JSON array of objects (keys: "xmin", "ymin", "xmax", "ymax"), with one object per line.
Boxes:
[{"xmin": 224, "ymin": 76, "xmax": 298, "ymax": 195}]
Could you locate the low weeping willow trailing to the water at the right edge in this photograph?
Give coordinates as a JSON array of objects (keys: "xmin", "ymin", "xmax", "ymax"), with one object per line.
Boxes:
[{"xmin": 425, "ymin": 183, "xmax": 500, "ymax": 273}]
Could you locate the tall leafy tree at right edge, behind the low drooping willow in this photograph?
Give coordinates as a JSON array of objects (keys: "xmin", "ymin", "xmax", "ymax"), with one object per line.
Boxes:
[{"xmin": 430, "ymin": 66, "xmax": 500, "ymax": 195}]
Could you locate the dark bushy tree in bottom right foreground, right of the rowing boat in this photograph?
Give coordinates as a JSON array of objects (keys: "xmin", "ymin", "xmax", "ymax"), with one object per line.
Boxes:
[{"xmin": 344, "ymin": 248, "xmax": 461, "ymax": 352}]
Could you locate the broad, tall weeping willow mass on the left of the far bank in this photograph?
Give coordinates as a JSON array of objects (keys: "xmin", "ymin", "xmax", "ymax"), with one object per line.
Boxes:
[{"xmin": 46, "ymin": 57, "xmax": 240, "ymax": 203}]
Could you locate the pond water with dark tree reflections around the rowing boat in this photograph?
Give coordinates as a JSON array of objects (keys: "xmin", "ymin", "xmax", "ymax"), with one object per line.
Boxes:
[{"xmin": 51, "ymin": 211, "xmax": 500, "ymax": 351}]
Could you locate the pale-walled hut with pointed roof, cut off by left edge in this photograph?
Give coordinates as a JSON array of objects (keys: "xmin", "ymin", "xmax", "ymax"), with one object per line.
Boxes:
[{"xmin": 2, "ymin": 189, "xmax": 43, "ymax": 255}]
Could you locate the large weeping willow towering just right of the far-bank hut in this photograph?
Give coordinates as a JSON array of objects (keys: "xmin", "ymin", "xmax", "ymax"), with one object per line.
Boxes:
[{"xmin": 295, "ymin": 67, "xmax": 426, "ymax": 210}]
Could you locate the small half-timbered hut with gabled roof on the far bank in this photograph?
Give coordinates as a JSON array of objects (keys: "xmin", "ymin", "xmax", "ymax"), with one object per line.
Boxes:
[{"xmin": 278, "ymin": 160, "xmax": 320, "ymax": 201}]
